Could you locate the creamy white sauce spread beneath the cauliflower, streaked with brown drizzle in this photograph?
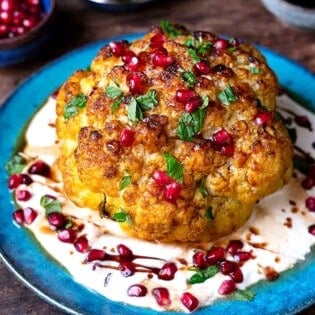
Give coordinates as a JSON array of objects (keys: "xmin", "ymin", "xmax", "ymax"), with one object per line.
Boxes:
[{"xmin": 18, "ymin": 95, "xmax": 315, "ymax": 311}]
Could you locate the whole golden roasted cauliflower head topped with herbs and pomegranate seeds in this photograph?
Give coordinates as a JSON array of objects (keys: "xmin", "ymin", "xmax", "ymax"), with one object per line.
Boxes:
[{"xmin": 56, "ymin": 22, "xmax": 292, "ymax": 242}]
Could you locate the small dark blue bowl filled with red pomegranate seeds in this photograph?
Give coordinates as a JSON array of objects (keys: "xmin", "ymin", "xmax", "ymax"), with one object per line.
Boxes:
[{"xmin": 0, "ymin": 0, "xmax": 55, "ymax": 67}]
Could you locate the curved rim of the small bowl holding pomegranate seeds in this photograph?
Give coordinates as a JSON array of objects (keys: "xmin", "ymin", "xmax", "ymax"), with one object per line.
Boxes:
[{"xmin": 0, "ymin": 0, "xmax": 56, "ymax": 50}]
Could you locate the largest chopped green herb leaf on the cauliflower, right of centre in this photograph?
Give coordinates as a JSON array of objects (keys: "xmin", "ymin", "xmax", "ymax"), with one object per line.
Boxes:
[{"xmin": 177, "ymin": 107, "xmax": 207, "ymax": 141}]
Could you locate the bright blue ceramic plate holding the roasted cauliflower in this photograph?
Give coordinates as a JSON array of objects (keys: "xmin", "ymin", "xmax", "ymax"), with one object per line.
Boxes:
[{"xmin": 0, "ymin": 34, "xmax": 315, "ymax": 315}]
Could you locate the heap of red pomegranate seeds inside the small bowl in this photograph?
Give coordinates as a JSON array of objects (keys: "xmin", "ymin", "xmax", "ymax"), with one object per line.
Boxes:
[{"xmin": 0, "ymin": 0, "xmax": 45, "ymax": 39}]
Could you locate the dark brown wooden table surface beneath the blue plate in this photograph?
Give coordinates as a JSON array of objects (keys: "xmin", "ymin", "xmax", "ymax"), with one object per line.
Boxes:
[{"xmin": 0, "ymin": 0, "xmax": 315, "ymax": 315}]
